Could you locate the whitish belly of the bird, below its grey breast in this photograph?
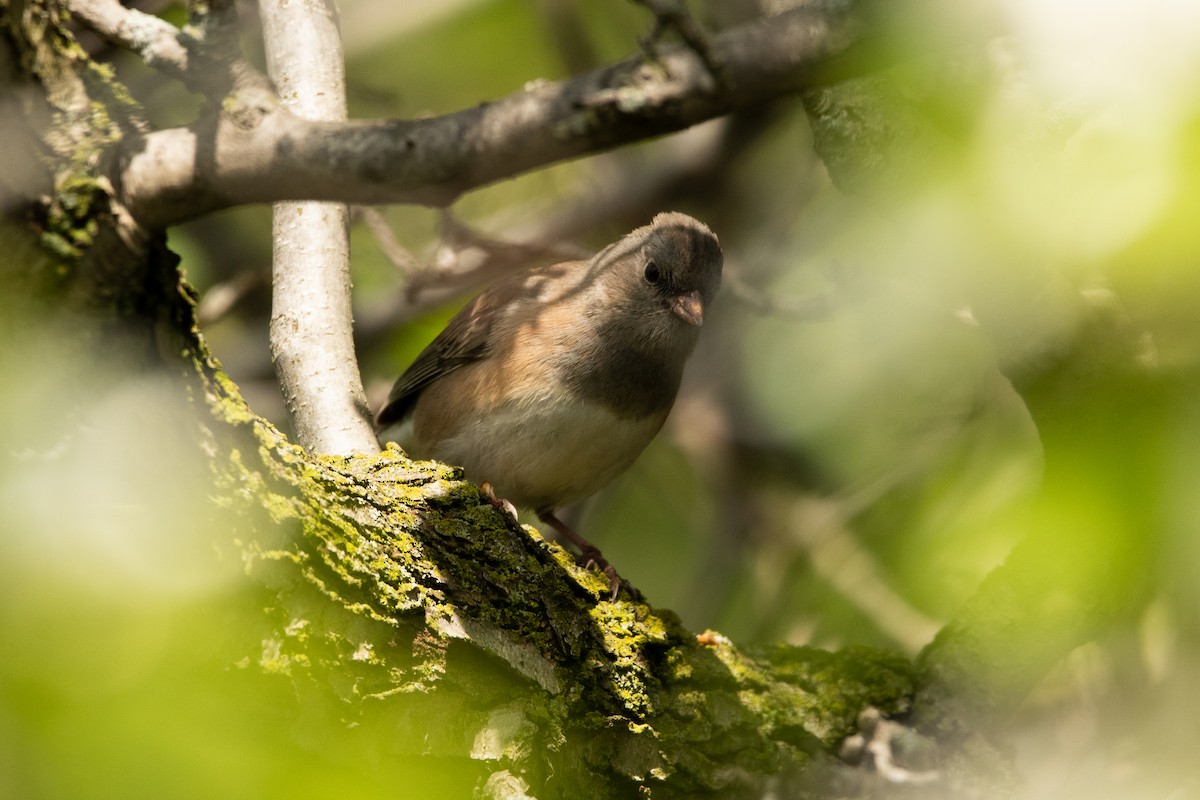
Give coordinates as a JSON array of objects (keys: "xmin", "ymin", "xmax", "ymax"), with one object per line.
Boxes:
[{"xmin": 418, "ymin": 388, "xmax": 666, "ymax": 511}]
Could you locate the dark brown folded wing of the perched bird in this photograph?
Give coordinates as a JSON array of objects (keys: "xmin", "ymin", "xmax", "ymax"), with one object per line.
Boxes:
[{"xmin": 376, "ymin": 278, "xmax": 520, "ymax": 429}]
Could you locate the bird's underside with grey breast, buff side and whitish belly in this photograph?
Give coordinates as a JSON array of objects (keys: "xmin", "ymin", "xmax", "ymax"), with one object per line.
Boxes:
[{"xmin": 414, "ymin": 291, "xmax": 694, "ymax": 510}]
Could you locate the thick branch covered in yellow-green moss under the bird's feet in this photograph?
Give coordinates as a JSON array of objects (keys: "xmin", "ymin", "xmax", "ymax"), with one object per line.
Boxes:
[{"xmin": 197, "ymin": 323, "xmax": 912, "ymax": 796}]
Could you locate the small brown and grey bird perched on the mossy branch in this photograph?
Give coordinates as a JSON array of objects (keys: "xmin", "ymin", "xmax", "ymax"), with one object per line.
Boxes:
[{"xmin": 376, "ymin": 212, "xmax": 722, "ymax": 596}]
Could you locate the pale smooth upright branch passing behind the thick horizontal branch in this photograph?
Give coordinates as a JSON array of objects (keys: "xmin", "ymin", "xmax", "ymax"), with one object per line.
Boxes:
[{"xmin": 259, "ymin": 0, "xmax": 379, "ymax": 455}]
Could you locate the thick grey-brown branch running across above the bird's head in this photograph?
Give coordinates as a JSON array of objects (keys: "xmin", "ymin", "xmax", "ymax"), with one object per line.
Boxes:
[{"xmin": 120, "ymin": 4, "xmax": 866, "ymax": 225}]
